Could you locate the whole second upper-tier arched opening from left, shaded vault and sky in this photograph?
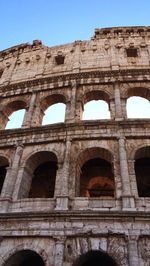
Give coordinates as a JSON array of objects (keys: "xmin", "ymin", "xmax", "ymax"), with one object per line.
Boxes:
[{"xmin": 41, "ymin": 94, "xmax": 66, "ymax": 125}]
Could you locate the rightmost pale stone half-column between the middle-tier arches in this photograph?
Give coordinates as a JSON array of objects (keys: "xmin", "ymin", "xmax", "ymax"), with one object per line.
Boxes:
[{"xmin": 119, "ymin": 137, "xmax": 135, "ymax": 209}]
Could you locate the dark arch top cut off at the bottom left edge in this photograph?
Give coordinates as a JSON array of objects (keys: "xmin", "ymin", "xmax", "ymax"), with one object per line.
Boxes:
[{"xmin": 4, "ymin": 249, "xmax": 45, "ymax": 266}]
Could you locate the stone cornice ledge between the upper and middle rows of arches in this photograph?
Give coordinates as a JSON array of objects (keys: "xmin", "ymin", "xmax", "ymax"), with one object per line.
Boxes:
[{"xmin": 0, "ymin": 119, "xmax": 150, "ymax": 147}]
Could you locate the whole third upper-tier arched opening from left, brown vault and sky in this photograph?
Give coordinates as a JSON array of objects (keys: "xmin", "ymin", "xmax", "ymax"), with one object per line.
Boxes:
[{"xmin": 82, "ymin": 91, "xmax": 111, "ymax": 120}]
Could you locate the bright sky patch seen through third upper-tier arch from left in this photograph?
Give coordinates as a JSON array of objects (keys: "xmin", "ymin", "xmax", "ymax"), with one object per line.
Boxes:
[{"xmin": 83, "ymin": 100, "xmax": 110, "ymax": 120}]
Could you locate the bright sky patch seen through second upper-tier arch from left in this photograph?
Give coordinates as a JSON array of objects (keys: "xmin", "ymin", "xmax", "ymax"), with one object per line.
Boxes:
[{"xmin": 42, "ymin": 103, "xmax": 66, "ymax": 125}]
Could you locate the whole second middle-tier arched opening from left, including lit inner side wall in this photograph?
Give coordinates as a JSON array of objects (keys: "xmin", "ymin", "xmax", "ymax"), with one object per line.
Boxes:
[{"xmin": 19, "ymin": 151, "xmax": 58, "ymax": 198}]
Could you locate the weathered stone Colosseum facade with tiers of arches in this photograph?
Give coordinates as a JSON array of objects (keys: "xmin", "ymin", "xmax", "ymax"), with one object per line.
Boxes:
[{"xmin": 0, "ymin": 26, "xmax": 150, "ymax": 266}]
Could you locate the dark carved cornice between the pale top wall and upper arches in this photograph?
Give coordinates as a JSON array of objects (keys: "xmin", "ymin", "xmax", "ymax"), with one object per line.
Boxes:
[{"xmin": 0, "ymin": 68, "xmax": 150, "ymax": 93}]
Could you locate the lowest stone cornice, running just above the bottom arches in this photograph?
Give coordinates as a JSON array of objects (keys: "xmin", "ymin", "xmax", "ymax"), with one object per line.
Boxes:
[{"xmin": 0, "ymin": 209, "xmax": 150, "ymax": 222}]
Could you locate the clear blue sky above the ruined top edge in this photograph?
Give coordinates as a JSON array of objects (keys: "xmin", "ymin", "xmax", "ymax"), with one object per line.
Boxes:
[{"xmin": 0, "ymin": 0, "xmax": 150, "ymax": 50}]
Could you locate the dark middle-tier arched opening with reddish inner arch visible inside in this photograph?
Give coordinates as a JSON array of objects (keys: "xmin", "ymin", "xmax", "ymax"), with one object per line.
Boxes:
[{"xmin": 80, "ymin": 158, "xmax": 114, "ymax": 197}]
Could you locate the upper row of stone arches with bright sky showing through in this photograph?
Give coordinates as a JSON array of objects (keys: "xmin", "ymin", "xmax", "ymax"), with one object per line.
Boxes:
[{"xmin": 0, "ymin": 85, "xmax": 150, "ymax": 129}]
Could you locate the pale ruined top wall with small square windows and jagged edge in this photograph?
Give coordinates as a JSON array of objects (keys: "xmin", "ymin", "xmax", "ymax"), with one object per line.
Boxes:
[{"xmin": 0, "ymin": 27, "xmax": 150, "ymax": 86}]
